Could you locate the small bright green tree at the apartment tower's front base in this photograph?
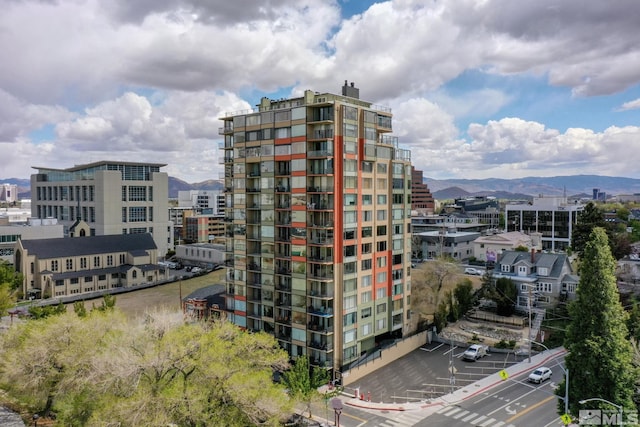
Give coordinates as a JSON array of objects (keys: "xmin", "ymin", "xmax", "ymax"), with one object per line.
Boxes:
[{"xmin": 283, "ymin": 356, "xmax": 329, "ymax": 418}]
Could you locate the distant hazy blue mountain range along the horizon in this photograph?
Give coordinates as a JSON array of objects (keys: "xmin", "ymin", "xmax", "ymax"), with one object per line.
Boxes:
[{"xmin": 0, "ymin": 175, "xmax": 640, "ymax": 200}]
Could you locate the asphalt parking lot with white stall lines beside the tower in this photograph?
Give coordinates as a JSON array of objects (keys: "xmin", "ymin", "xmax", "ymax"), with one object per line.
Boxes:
[{"xmin": 346, "ymin": 342, "xmax": 522, "ymax": 403}]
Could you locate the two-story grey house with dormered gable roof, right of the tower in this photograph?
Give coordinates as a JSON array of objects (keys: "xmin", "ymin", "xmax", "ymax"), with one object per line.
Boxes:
[{"xmin": 493, "ymin": 250, "xmax": 579, "ymax": 311}]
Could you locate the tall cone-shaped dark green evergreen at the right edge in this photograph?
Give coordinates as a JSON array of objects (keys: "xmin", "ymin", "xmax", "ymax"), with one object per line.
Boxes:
[{"xmin": 557, "ymin": 227, "xmax": 638, "ymax": 415}]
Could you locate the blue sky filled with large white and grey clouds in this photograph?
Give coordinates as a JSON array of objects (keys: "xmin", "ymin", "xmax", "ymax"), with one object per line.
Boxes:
[{"xmin": 0, "ymin": 0, "xmax": 640, "ymax": 182}]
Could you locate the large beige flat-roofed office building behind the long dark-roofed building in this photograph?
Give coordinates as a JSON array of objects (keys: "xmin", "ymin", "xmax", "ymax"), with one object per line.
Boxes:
[{"xmin": 31, "ymin": 161, "xmax": 173, "ymax": 256}]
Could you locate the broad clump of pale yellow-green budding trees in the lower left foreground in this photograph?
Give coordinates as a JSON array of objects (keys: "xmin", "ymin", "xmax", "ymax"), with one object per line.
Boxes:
[{"xmin": 0, "ymin": 309, "xmax": 292, "ymax": 427}]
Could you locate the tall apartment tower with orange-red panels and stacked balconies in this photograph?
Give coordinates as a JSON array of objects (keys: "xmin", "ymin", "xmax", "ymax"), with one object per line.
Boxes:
[{"xmin": 220, "ymin": 83, "xmax": 411, "ymax": 372}]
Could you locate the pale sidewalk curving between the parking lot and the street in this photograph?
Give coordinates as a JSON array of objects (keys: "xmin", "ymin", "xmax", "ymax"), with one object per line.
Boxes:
[{"xmin": 343, "ymin": 348, "xmax": 566, "ymax": 416}]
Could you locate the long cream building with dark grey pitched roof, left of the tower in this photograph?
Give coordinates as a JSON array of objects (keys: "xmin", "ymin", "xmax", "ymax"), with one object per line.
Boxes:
[{"xmin": 14, "ymin": 234, "xmax": 167, "ymax": 298}]
